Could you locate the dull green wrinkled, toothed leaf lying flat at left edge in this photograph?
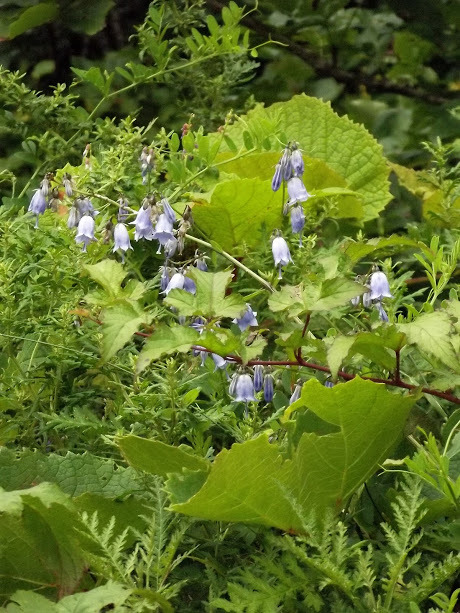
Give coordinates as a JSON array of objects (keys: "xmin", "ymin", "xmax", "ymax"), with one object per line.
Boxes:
[{"xmin": 0, "ymin": 447, "xmax": 140, "ymax": 497}]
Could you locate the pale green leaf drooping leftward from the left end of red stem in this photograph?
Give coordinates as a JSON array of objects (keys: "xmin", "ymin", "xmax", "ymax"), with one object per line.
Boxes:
[{"xmin": 136, "ymin": 322, "xmax": 200, "ymax": 372}]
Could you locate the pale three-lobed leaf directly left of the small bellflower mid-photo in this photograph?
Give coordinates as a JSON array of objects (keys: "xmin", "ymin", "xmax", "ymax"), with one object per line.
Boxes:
[{"xmin": 165, "ymin": 268, "xmax": 246, "ymax": 318}]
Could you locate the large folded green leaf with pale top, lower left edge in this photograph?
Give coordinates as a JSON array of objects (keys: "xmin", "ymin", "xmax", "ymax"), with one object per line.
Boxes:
[{"xmin": 0, "ymin": 483, "xmax": 85, "ymax": 596}]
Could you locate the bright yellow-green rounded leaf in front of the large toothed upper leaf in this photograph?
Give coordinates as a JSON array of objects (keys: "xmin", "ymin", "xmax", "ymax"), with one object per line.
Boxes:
[{"xmin": 193, "ymin": 179, "xmax": 282, "ymax": 254}]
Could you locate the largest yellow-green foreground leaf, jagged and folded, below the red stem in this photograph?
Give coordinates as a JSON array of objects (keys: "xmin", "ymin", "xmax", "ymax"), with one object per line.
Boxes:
[{"xmin": 165, "ymin": 378, "xmax": 415, "ymax": 531}]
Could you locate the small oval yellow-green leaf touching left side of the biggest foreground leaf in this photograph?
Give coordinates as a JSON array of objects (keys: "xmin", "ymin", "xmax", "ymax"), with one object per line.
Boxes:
[{"xmin": 116, "ymin": 435, "xmax": 209, "ymax": 477}]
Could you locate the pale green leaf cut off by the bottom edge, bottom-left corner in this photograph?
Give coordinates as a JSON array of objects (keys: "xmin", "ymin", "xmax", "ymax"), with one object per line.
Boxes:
[{"xmin": 6, "ymin": 581, "xmax": 131, "ymax": 613}]
